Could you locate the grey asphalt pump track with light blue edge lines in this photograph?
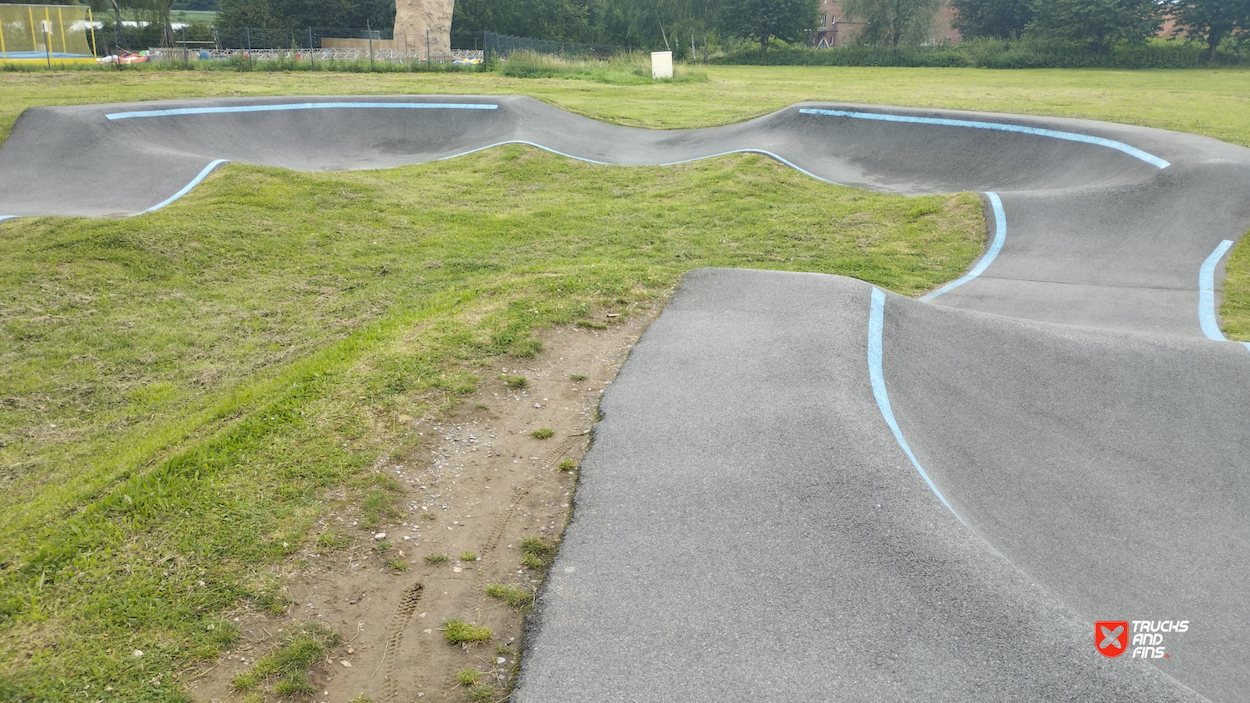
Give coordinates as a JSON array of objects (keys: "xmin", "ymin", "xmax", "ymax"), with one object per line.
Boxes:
[{"xmin": 0, "ymin": 96, "xmax": 1250, "ymax": 703}]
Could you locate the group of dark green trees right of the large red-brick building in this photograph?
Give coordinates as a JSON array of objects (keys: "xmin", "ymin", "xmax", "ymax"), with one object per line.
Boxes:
[{"xmin": 950, "ymin": 0, "xmax": 1250, "ymax": 59}]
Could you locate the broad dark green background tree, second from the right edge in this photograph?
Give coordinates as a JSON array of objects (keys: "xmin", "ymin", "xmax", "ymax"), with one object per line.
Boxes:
[{"xmin": 1029, "ymin": 0, "xmax": 1163, "ymax": 54}]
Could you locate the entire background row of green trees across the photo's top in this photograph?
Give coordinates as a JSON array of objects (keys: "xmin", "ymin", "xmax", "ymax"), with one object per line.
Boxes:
[{"xmin": 7, "ymin": 0, "xmax": 1250, "ymax": 59}]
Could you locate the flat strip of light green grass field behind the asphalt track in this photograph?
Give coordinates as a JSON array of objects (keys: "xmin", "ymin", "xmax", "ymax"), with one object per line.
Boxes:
[{"xmin": 0, "ymin": 66, "xmax": 1250, "ymax": 146}]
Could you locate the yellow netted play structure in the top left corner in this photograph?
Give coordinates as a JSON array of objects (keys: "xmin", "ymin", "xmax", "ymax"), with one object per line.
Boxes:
[{"xmin": 0, "ymin": 5, "xmax": 95, "ymax": 66}]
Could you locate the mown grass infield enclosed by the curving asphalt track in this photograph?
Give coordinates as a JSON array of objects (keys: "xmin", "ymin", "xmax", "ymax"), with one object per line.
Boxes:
[{"xmin": 0, "ymin": 146, "xmax": 984, "ymax": 700}]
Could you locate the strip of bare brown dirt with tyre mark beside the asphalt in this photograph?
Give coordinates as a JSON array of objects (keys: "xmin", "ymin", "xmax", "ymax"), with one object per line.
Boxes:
[{"xmin": 188, "ymin": 308, "xmax": 659, "ymax": 703}]
